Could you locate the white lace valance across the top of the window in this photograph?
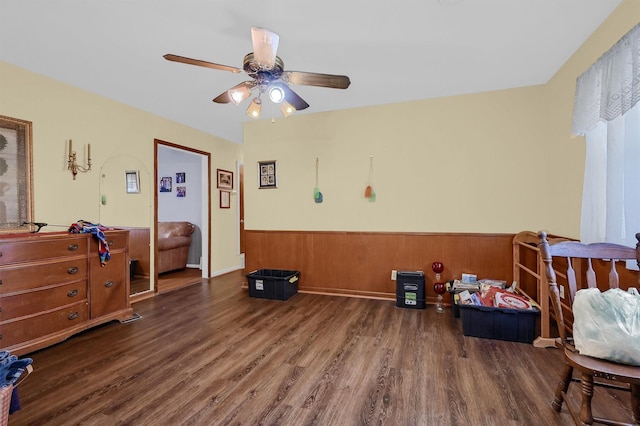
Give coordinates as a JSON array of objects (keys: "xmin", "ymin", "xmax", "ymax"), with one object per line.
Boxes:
[{"xmin": 572, "ymin": 24, "xmax": 640, "ymax": 135}]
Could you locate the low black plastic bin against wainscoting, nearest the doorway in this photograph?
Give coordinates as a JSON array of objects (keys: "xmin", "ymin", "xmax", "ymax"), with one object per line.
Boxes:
[{"xmin": 247, "ymin": 269, "xmax": 300, "ymax": 300}]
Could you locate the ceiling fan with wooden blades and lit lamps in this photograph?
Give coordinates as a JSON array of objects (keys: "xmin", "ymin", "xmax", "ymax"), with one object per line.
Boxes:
[{"xmin": 164, "ymin": 27, "xmax": 351, "ymax": 118}]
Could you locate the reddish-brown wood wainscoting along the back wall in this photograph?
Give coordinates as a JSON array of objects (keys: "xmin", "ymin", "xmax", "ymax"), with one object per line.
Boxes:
[{"xmin": 245, "ymin": 230, "xmax": 514, "ymax": 303}]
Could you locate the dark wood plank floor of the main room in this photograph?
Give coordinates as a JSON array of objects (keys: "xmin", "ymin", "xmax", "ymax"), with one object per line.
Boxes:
[{"xmin": 9, "ymin": 272, "xmax": 629, "ymax": 426}]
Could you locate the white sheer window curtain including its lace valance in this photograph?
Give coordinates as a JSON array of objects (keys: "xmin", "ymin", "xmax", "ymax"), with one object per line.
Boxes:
[{"xmin": 573, "ymin": 24, "xmax": 640, "ymax": 253}]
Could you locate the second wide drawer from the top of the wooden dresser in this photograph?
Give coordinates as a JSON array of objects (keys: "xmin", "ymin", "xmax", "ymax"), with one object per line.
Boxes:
[{"xmin": 0, "ymin": 257, "xmax": 87, "ymax": 294}]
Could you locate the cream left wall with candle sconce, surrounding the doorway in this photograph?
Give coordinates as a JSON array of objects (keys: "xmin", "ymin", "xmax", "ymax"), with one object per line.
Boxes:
[{"xmin": 0, "ymin": 62, "xmax": 242, "ymax": 275}]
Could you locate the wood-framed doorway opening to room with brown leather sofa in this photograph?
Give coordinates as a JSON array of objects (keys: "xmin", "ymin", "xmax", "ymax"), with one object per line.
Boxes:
[{"xmin": 154, "ymin": 139, "xmax": 211, "ymax": 293}]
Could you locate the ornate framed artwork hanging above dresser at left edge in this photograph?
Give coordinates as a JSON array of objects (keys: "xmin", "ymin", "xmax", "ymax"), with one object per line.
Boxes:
[{"xmin": 0, "ymin": 115, "xmax": 33, "ymax": 233}]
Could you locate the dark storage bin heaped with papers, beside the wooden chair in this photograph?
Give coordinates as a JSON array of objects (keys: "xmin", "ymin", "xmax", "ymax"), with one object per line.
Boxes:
[{"xmin": 458, "ymin": 305, "xmax": 540, "ymax": 343}]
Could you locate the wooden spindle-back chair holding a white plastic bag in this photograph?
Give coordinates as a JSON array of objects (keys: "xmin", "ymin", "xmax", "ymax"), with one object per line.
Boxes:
[{"xmin": 538, "ymin": 231, "xmax": 640, "ymax": 425}]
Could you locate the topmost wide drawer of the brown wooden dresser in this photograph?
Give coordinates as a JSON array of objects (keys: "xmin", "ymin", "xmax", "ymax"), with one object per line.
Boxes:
[{"xmin": 0, "ymin": 236, "xmax": 88, "ymax": 266}]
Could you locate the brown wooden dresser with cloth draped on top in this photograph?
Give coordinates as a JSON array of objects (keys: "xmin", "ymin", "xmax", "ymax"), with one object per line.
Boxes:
[{"xmin": 0, "ymin": 230, "xmax": 133, "ymax": 355}]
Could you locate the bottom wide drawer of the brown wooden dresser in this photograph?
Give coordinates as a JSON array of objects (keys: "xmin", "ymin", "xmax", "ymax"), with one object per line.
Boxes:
[{"xmin": 0, "ymin": 302, "xmax": 87, "ymax": 348}]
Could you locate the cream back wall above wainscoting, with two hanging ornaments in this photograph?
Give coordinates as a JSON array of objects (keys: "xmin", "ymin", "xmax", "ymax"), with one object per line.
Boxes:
[{"xmin": 244, "ymin": 0, "xmax": 640, "ymax": 238}]
